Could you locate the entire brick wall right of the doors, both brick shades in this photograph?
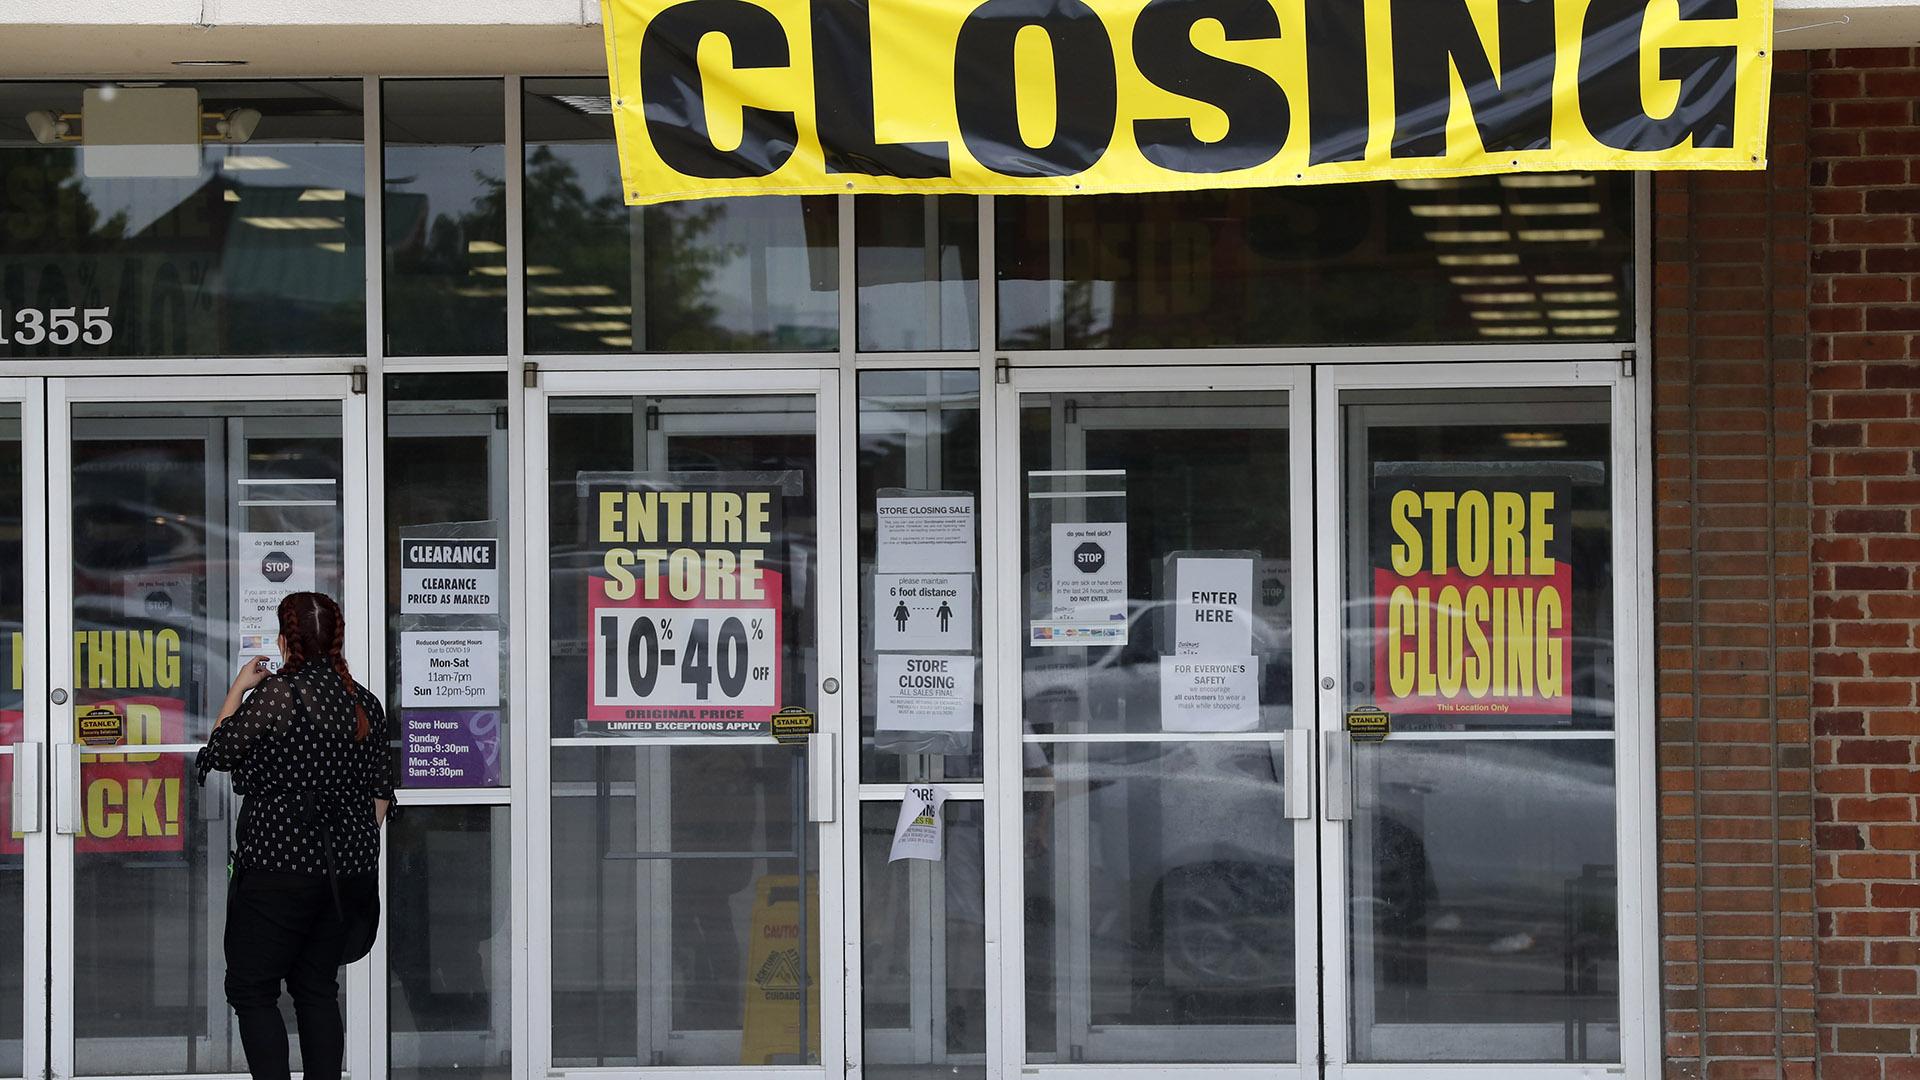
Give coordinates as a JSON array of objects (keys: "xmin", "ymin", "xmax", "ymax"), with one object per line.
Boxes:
[{"xmin": 1655, "ymin": 48, "xmax": 1920, "ymax": 1080}]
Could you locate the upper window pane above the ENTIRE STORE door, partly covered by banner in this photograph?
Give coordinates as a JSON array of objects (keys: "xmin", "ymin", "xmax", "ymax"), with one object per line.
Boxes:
[{"xmin": 524, "ymin": 79, "xmax": 839, "ymax": 354}]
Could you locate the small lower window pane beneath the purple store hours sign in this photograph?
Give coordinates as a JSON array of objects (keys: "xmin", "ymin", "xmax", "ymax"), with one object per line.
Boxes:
[{"xmin": 384, "ymin": 805, "xmax": 513, "ymax": 1080}]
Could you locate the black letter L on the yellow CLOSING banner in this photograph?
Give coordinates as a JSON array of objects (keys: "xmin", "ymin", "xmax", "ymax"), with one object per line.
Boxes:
[{"xmin": 812, "ymin": 0, "xmax": 952, "ymax": 181}]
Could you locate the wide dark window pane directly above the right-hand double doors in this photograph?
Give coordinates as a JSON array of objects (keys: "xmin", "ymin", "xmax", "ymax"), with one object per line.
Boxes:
[{"xmin": 995, "ymin": 173, "xmax": 1634, "ymax": 350}]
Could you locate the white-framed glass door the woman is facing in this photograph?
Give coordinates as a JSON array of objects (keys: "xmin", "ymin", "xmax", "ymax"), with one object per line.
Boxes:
[{"xmin": 48, "ymin": 377, "xmax": 365, "ymax": 1076}]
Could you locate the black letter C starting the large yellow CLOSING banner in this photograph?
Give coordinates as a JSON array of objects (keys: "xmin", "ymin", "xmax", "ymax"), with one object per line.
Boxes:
[{"xmin": 639, "ymin": 0, "xmax": 799, "ymax": 181}]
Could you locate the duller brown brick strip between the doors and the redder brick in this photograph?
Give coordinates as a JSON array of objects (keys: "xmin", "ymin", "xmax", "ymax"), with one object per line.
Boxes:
[{"xmin": 1653, "ymin": 52, "xmax": 1814, "ymax": 1080}]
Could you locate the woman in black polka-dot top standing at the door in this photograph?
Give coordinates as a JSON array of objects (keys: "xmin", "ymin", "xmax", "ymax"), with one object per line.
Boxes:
[{"xmin": 198, "ymin": 592, "xmax": 394, "ymax": 1080}]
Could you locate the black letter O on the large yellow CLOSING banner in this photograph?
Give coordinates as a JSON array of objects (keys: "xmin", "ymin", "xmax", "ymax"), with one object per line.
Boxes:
[{"xmin": 954, "ymin": 0, "xmax": 1119, "ymax": 177}]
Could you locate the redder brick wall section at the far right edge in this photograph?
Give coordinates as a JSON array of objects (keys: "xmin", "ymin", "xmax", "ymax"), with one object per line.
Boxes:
[{"xmin": 1809, "ymin": 48, "xmax": 1920, "ymax": 1080}]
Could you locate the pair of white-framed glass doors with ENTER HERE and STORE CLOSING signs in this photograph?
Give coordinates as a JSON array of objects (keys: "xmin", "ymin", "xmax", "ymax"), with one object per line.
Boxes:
[{"xmin": 989, "ymin": 363, "xmax": 1645, "ymax": 1080}]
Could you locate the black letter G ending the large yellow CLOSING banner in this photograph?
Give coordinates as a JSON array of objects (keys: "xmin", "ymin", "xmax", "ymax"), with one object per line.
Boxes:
[{"xmin": 1580, "ymin": 0, "xmax": 1740, "ymax": 150}]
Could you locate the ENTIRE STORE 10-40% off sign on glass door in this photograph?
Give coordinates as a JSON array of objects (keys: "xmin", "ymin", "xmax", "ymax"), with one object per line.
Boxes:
[{"xmin": 584, "ymin": 484, "xmax": 785, "ymax": 736}]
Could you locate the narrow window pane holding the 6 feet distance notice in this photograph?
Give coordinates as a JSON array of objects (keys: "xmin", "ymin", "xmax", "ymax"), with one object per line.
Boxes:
[{"xmin": 858, "ymin": 371, "xmax": 983, "ymax": 784}]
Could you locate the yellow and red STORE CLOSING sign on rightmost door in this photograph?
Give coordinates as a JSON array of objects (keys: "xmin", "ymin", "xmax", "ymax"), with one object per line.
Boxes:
[{"xmin": 1373, "ymin": 477, "xmax": 1572, "ymax": 717}]
